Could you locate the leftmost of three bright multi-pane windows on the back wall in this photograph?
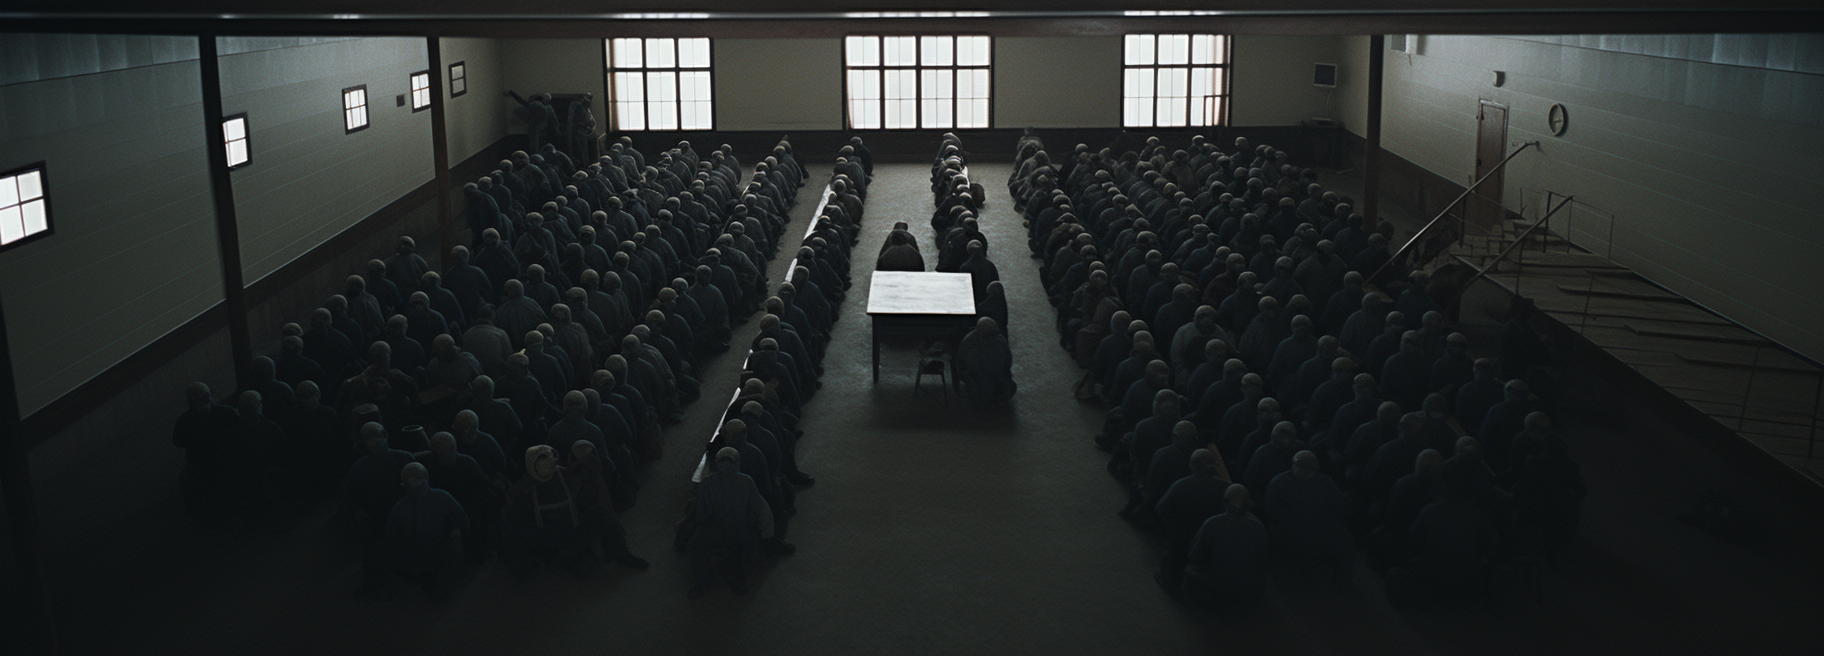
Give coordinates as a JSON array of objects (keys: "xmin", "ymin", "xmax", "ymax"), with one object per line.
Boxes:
[{"xmin": 606, "ymin": 38, "xmax": 715, "ymax": 129}]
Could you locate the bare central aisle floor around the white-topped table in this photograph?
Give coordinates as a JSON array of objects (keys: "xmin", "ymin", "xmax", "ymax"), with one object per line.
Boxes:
[{"xmin": 747, "ymin": 164, "xmax": 1204, "ymax": 652}]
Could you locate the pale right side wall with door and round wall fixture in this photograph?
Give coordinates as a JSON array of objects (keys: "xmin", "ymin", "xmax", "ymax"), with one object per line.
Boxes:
[{"xmin": 1383, "ymin": 35, "xmax": 1824, "ymax": 359}]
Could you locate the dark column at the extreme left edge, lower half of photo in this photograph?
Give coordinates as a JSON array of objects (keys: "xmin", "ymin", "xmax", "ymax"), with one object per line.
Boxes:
[{"xmin": 0, "ymin": 295, "xmax": 57, "ymax": 654}]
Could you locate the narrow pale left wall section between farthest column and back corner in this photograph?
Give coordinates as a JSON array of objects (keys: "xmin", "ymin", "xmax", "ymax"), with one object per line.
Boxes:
[{"xmin": 446, "ymin": 38, "xmax": 511, "ymax": 166}]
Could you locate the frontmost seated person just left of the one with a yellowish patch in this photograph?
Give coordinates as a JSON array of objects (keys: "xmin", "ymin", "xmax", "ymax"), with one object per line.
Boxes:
[{"xmin": 359, "ymin": 461, "xmax": 469, "ymax": 598}]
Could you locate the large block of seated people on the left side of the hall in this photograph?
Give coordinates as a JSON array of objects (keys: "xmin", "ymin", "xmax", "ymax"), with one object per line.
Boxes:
[{"xmin": 173, "ymin": 133, "xmax": 828, "ymax": 594}]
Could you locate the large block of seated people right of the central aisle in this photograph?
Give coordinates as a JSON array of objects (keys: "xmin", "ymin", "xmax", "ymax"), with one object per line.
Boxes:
[{"xmin": 1009, "ymin": 135, "xmax": 1583, "ymax": 603}]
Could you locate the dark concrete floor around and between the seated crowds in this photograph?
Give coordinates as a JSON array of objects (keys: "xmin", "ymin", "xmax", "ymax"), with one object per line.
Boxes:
[{"xmin": 17, "ymin": 164, "xmax": 1824, "ymax": 654}]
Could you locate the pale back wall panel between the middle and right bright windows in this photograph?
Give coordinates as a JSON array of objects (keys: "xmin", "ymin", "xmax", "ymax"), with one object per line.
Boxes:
[{"xmin": 992, "ymin": 36, "xmax": 1122, "ymax": 128}]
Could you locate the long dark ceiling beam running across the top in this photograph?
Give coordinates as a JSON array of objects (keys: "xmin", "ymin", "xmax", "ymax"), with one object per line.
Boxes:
[{"xmin": 0, "ymin": 8, "xmax": 1824, "ymax": 38}]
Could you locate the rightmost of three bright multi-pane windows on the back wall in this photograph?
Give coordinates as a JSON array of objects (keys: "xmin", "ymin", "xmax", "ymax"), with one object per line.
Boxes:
[{"xmin": 1122, "ymin": 35, "xmax": 1229, "ymax": 128}]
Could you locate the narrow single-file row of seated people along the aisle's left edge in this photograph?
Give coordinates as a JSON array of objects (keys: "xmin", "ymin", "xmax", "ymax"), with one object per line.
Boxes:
[{"xmin": 677, "ymin": 143, "xmax": 874, "ymax": 600}]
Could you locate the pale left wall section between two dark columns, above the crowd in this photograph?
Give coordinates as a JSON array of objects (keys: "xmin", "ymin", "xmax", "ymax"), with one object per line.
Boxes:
[{"xmin": 217, "ymin": 36, "xmax": 438, "ymax": 284}]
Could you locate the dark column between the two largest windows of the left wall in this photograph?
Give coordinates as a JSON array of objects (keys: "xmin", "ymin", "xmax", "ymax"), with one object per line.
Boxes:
[{"xmin": 197, "ymin": 35, "xmax": 254, "ymax": 388}]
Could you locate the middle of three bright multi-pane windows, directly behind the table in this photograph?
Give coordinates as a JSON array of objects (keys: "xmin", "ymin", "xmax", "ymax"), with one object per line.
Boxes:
[{"xmin": 845, "ymin": 36, "xmax": 992, "ymax": 129}]
